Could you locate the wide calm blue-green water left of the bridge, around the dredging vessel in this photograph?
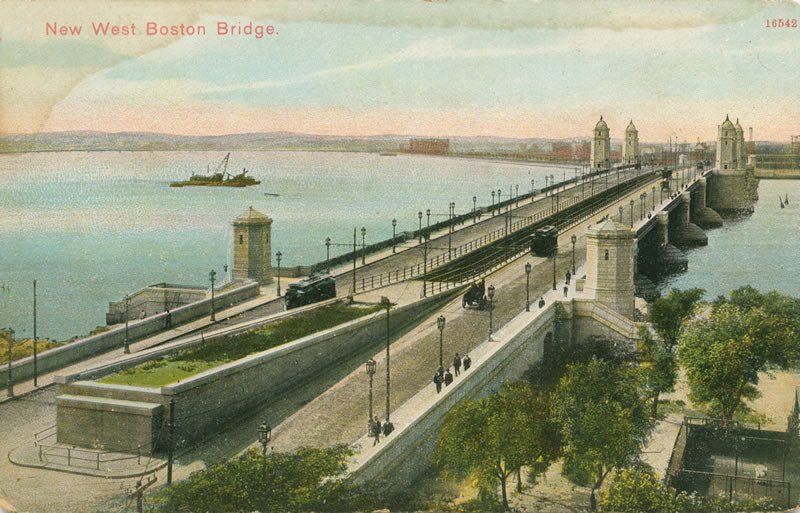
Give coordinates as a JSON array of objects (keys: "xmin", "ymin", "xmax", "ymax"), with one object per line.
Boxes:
[{"xmin": 0, "ymin": 151, "xmax": 576, "ymax": 339}]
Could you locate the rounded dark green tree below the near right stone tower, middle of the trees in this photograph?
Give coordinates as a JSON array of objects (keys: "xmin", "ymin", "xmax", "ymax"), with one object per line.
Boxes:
[{"xmin": 553, "ymin": 359, "xmax": 650, "ymax": 510}]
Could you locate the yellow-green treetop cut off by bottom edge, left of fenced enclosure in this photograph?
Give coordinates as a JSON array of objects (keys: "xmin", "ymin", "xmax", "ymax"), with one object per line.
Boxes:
[{"xmin": 598, "ymin": 468, "xmax": 674, "ymax": 513}]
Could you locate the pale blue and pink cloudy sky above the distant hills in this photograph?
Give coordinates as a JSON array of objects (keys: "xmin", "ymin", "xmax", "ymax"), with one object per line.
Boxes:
[{"xmin": 0, "ymin": 0, "xmax": 800, "ymax": 142}]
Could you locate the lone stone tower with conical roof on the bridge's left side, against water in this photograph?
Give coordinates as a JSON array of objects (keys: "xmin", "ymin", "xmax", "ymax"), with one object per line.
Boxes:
[{"xmin": 231, "ymin": 207, "xmax": 272, "ymax": 285}]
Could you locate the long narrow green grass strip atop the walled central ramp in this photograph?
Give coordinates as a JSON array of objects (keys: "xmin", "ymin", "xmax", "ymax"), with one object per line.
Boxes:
[{"xmin": 98, "ymin": 303, "xmax": 381, "ymax": 387}]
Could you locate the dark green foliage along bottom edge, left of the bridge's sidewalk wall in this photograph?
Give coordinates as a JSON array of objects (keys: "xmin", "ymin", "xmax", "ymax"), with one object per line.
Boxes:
[{"xmin": 155, "ymin": 446, "xmax": 364, "ymax": 513}]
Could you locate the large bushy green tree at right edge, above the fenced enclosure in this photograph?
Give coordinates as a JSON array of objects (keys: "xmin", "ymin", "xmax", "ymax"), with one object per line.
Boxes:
[{"xmin": 678, "ymin": 288, "xmax": 800, "ymax": 422}]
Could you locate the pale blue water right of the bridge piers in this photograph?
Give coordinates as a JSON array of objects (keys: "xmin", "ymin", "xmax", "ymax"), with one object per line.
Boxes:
[{"xmin": 661, "ymin": 180, "xmax": 800, "ymax": 300}]
